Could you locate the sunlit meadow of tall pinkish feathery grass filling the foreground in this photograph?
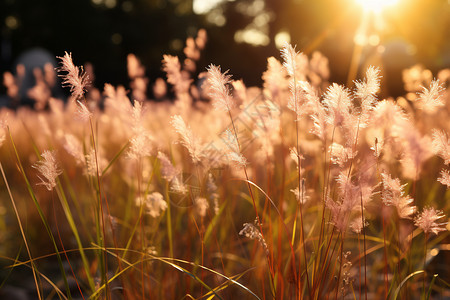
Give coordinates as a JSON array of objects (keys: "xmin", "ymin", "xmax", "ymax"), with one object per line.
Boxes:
[{"xmin": 0, "ymin": 31, "xmax": 450, "ymax": 299}]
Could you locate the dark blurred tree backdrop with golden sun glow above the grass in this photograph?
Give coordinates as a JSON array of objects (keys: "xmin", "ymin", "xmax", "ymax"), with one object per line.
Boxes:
[{"xmin": 0, "ymin": 0, "xmax": 450, "ymax": 97}]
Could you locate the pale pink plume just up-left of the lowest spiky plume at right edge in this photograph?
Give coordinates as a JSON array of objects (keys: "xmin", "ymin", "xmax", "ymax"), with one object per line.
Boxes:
[{"xmin": 381, "ymin": 173, "xmax": 416, "ymax": 219}]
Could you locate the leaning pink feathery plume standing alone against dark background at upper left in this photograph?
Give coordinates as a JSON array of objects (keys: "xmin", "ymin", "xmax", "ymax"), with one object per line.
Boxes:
[{"xmin": 57, "ymin": 52, "xmax": 89, "ymax": 100}]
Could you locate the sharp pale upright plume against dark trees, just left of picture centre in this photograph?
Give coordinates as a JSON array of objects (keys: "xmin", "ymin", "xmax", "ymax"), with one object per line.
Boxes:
[{"xmin": 208, "ymin": 64, "xmax": 234, "ymax": 111}]
